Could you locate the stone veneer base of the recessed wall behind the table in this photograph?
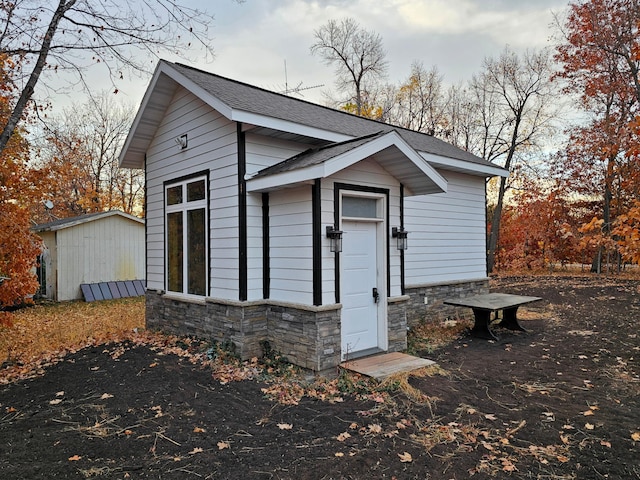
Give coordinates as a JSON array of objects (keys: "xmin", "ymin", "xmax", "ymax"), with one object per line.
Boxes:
[{"xmin": 405, "ymin": 278, "xmax": 489, "ymax": 327}]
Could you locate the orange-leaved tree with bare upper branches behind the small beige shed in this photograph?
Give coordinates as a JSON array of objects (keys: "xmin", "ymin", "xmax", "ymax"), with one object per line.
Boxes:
[{"xmin": 32, "ymin": 92, "xmax": 144, "ymax": 223}]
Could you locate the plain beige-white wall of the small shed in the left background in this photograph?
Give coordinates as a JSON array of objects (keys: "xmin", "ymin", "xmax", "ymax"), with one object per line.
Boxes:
[{"xmin": 56, "ymin": 215, "xmax": 145, "ymax": 301}]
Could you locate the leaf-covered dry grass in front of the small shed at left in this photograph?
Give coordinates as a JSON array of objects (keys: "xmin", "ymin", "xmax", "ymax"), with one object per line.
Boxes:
[{"xmin": 0, "ymin": 297, "xmax": 145, "ymax": 364}]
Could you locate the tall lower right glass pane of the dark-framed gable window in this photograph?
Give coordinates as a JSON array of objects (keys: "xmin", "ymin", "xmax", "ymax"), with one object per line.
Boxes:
[{"xmin": 187, "ymin": 208, "xmax": 207, "ymax": 295}]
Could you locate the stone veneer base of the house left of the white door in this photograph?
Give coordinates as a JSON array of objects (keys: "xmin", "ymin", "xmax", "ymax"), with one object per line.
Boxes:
[{"xmin": 145, "ymin": 291, "xmax": 341, "ymax": 371}]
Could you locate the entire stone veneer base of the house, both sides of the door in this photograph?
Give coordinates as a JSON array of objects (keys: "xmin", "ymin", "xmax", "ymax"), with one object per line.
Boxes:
[{"xmin": 146, "ymin": 279, "xmax": 489, "ymax": 372}]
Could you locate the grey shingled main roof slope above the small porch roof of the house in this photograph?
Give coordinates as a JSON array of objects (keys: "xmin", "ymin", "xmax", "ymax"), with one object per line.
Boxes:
[{"xmin": 168, "ymin": 60, "xmax": 492, "ymax": 168}]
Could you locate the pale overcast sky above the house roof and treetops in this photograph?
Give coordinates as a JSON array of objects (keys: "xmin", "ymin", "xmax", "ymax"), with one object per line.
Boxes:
[{"xmin": 54, "ymin": 0, "xmax": 568, "ymax": 110}]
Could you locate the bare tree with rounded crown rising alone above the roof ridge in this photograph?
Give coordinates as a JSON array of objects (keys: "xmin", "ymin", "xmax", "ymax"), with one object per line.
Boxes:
[{"xmin": 311, "ymin": 18, "xmax": 387, "ymax": 115}]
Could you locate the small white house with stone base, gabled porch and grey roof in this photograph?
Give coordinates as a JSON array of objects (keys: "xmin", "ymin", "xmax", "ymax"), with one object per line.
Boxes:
[{"xmin": 120, "ymin": 61, "xmax": 508, "ymax": 371}]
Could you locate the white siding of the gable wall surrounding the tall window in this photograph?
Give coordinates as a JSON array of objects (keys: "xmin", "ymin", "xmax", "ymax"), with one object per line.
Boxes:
[{"xmin": 146, "ymin": 88, "xmax": 238, "ymax": 300}]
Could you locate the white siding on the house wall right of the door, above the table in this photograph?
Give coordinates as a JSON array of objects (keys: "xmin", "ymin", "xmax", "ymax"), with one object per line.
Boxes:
[{"xmin": 405, "ymin": 172, "xmax": 487, "ymax": 286}]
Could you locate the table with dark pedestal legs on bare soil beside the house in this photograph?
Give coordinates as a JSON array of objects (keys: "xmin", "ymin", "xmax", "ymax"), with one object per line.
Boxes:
[{"xmin": 443, "ymin": 293, "xmax": 542, "ymax": 340}]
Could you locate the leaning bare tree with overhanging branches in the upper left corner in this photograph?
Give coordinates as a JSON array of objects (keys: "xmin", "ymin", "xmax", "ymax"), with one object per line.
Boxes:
[{"xmin": 0, "ymin": 0, "xmax": 221, "ymax": 155}]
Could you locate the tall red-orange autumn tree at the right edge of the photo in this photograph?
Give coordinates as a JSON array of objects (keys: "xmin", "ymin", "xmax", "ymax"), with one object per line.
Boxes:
[{"xmin": 556, "ymin": 0, "xmax": 640, "ymax": 271}]
